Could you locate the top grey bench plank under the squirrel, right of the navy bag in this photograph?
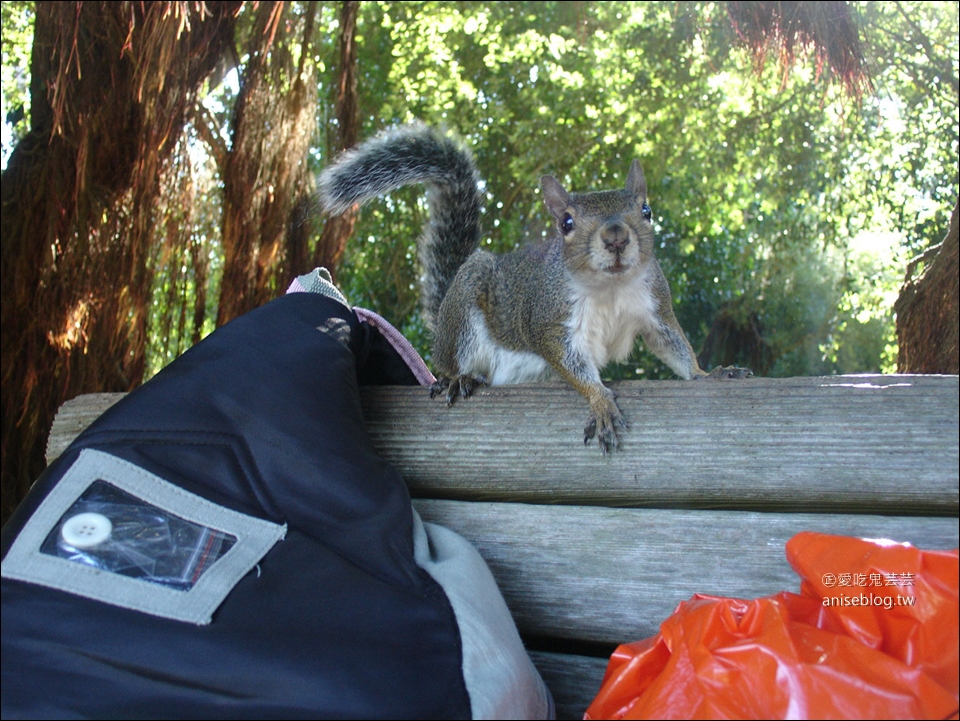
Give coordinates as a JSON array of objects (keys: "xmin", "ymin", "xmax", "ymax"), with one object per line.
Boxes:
[{"xmin": 361, "ymin": 376, "xmax": 960, "ymax": 516}]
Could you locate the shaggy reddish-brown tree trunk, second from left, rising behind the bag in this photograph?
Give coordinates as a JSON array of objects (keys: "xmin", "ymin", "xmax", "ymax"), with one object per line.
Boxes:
[{"xmin": 217, "ymin": 2, "xmax": 317, "ymax": 326}]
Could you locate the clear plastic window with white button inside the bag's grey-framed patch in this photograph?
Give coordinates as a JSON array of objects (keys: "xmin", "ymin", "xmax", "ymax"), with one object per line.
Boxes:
[{"xmin": 40, "ymin": 480, "xmax": 237, "ymax": 591}]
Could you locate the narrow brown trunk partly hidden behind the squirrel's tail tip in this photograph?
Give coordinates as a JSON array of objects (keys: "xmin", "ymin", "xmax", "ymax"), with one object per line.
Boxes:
[{"xmin": 315, "ymin": 0, "xmax": 360, "ymax": 279}]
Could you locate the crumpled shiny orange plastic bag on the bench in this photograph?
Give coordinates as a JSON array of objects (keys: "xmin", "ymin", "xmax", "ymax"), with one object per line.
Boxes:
[{"xmin": 584, "ymin": 532, "xmax": 960, "ymax": 719}]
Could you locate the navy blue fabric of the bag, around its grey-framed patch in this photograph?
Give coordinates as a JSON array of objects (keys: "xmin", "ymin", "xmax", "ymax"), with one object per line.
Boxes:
[{"xmin": 2, "ymin": 293, "xmax": 470, "ymax": 718}]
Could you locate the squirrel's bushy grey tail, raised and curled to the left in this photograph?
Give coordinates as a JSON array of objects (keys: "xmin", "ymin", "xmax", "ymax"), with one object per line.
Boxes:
[{"xmin": 318, "ymin": 124, "xmax": 483, "ymax": 329}]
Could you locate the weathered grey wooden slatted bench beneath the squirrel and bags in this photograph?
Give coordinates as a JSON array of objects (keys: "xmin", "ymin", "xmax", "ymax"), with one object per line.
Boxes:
[{"xmin": 47, "ymin": 376, "xmax": 960, "ymax": 718}]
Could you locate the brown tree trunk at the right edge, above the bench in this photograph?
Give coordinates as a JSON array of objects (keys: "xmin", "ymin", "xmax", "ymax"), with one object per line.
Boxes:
[{"xmin": 894, "ymin": 200, "xmax": 960, "ymax": 375}]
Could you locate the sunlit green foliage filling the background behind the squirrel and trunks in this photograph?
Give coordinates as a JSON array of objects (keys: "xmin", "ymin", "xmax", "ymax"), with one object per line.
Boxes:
[{"xmin": 2, "ymin": 1, "xmax": 960, "ymax": 378}]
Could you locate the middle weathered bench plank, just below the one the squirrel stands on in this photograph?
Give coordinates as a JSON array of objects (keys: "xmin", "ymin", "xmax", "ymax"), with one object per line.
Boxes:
[{"xmin": 414, "ymin": 499, "xmax": 960, "ymax": 644}]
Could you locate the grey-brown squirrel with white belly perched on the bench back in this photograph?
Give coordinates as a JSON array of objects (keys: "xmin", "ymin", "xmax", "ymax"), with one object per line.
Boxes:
[{"xmin": 317, "ymin": 123, "xmax": 752, "ymax": 453}]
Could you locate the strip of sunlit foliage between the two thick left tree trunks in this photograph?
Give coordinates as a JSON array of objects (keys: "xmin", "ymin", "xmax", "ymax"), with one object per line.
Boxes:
[{"xmin": 147, "ymin": 3, "xmax": 336, "ymax": 377}]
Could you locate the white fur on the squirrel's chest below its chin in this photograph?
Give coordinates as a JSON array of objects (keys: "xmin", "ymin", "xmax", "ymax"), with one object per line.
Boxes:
[{"xmin": 567, "ymin": 266, "xmax": 657, "ymax": 370}]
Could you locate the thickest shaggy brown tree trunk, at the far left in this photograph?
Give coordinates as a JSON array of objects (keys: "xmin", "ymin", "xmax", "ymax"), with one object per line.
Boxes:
[{"xmin": 0, "ymin": 2, "xmax": 239, "ymax": 520}]
